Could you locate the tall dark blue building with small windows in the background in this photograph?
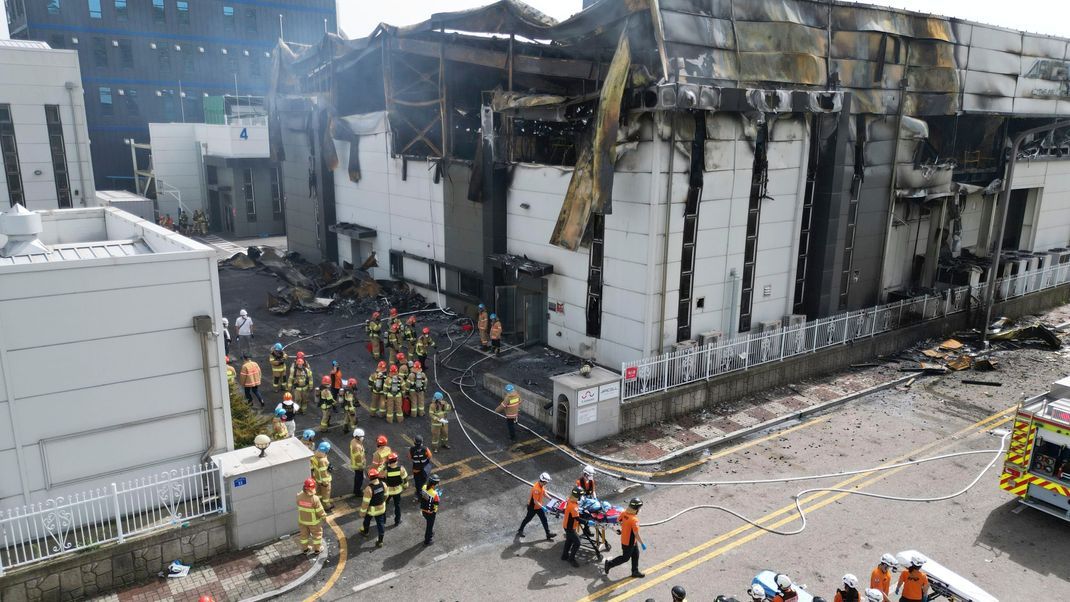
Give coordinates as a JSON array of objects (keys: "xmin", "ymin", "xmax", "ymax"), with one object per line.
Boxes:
[{"xmin": 12, "ymin": 0, "xmax": 337, "ymax": 188}]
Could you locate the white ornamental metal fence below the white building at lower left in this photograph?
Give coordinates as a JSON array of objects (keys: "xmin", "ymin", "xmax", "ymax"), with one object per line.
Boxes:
[{"xmin": 0, "ymin": 463, "xmax": 227, "ymax": 575}]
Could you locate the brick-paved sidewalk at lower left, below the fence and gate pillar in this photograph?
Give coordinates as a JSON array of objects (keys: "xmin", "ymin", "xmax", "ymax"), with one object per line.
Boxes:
[{"xmin": 92, "ymin": 538, "xmax": 326, "ymax": 602}]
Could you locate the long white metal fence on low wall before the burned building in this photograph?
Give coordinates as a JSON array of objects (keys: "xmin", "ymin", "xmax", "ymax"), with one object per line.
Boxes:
[{"xmin": 621, "ymin": 263, "xmax": 1070, "ymax": 400}]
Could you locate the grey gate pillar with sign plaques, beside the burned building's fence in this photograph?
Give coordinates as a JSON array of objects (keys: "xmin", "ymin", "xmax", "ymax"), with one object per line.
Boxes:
[{"xmin": 550, "ymin": 366, "xmax": 621, "ymax": 445}]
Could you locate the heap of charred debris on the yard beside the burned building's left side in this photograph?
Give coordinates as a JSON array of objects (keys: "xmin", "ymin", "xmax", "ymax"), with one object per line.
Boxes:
[{"xmin": 220, "ymin": 246, "xmax": 430, "ymax": 315}]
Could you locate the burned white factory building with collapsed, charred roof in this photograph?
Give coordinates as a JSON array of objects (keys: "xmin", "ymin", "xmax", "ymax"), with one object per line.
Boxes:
[{"xmin": 269, "ymin": 0, "xmax": 1070, "ymax": 366}]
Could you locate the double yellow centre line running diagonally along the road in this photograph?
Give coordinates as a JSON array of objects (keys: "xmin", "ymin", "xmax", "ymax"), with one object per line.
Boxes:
[{"xmin": 584, "ymin": 413, "xmax": 1012, "ymax": 602}]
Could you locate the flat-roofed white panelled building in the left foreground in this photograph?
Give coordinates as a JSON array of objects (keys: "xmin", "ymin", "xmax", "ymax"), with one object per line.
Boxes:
[{"xmin": 0, "ymin": 206, "xmax": 233, "ymax": 508}]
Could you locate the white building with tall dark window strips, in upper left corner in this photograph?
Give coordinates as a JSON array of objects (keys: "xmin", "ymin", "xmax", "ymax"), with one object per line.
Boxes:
[{"xmin": 0, "ymin": 36, "xmax": 94, "ymax": 211}]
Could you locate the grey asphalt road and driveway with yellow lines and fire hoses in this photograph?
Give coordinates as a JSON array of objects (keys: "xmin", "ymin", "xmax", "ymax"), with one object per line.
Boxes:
[{"xmin": 223, "ymin": 268, "xmax": 1070, "ymax": 601}]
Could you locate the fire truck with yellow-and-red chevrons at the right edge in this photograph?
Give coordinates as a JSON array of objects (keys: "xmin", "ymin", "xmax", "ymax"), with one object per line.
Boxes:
[{"xmin": 999, "ymin": 377, "xmax": 1070, "ymax": 521}]
